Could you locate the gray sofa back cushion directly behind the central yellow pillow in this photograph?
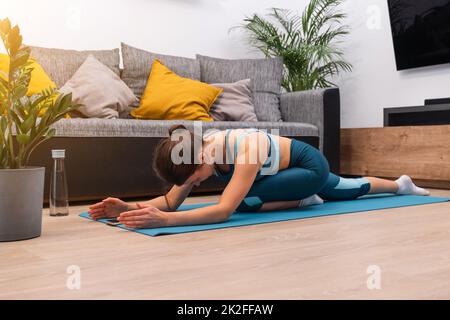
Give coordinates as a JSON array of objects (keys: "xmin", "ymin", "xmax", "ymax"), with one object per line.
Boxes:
[{"xmin": 122, "ymin": 43, "xmax": 200, "ymax": 106}]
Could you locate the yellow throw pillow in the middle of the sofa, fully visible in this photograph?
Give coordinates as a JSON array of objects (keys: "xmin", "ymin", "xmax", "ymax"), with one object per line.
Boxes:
[{"xmin": 131, "ymin": 60, "xmax": 223, "ymax": 121}]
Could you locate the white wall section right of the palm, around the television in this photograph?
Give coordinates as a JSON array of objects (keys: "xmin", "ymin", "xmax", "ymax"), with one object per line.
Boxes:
[{"xmin": 339, "ymin": 0, "xmax": 450, "ymax": 128}]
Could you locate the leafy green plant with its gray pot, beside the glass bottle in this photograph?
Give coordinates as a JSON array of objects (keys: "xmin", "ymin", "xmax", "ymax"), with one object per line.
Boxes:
[{"xmin": 0, "ymin": 19, "xmax": 78, "ymax": 241}]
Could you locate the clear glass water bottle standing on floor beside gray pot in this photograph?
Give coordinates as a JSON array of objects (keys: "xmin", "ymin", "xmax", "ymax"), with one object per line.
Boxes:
[{"xmin": 49, "ymin": 150, "xmax": 69, "ymax": 217}]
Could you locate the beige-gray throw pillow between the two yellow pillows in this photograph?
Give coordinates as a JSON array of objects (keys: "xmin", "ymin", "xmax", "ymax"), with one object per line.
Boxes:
[{"xmin": 59, "ymin": 55, "xmax": 136, "ymax": 119}]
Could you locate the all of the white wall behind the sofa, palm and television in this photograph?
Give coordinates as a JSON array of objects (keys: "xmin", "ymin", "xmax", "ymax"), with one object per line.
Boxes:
[{"xmin": 0, "ymin": 0, "xmax": 450, "ymax": 128}]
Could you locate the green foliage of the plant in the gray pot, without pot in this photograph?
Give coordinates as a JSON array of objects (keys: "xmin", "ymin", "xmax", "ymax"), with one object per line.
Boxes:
[{"xmin": 0, "ymin": 19, "xmax": 79, "ymax": 169}]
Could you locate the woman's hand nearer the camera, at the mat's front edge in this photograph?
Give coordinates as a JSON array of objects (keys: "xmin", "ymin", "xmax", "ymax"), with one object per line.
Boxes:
[{"xmin": 117, "ymin": 204, "xmax": 168, "ymax": 229}]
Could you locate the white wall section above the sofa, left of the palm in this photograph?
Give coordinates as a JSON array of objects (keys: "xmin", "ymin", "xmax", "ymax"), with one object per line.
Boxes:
[{"xmin": 0, "ymin": 0, "xmax": 303, "ymax": 58}]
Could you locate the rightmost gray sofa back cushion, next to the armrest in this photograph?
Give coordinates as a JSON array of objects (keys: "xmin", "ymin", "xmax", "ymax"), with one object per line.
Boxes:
[{"xmin": 197, "ymin": 55, "xmax": 283, "ymax": 121}]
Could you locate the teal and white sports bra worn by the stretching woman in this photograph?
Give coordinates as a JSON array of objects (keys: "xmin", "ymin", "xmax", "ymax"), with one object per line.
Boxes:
[{"xmin": 214, "ymin": 128, "xmax": 280, "ymax": 181}]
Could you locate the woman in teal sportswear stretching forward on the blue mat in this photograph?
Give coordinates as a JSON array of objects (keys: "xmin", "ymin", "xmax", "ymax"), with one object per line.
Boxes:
[{"xmin": 89, "ymin": 125, "xmax": 430, "ymax": 228}]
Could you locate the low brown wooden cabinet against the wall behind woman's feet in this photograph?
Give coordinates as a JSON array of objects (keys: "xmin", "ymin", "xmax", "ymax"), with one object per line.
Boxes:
[{"xmin": 340, "ymin": 125, "xmax": 450, "ymax": 189}]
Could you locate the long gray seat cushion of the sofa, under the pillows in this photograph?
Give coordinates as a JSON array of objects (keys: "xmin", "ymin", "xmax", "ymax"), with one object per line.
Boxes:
[{"xmin": 52, "ymin": 118, "xmax": 319, "ymax": 137}]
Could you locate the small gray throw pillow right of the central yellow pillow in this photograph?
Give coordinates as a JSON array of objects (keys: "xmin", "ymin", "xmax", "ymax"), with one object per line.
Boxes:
[{"xmin": 209, "ymin": 79, "xmax": 258, "ymax": 122}]
